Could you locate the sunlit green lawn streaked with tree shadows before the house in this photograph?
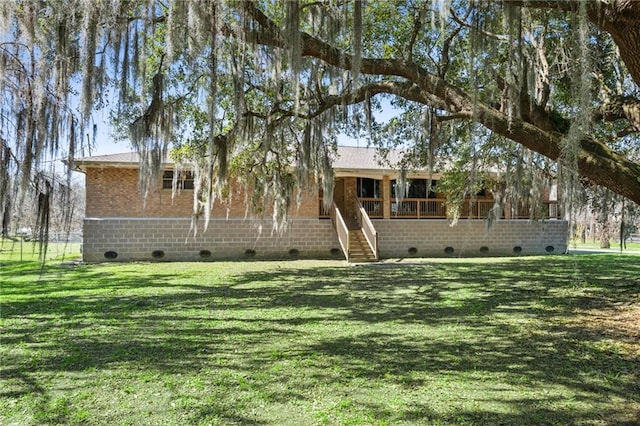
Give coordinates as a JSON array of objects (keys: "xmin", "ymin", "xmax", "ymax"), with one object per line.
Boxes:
[{"xmin": 0, "ymin": 254, "xmax": 640, "ymax": 425}]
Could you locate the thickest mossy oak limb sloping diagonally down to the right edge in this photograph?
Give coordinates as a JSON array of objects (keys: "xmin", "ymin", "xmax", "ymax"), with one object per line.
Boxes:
[{"xmin": 242, "ymin": 2, "xmax": 640, "ymax": 204}]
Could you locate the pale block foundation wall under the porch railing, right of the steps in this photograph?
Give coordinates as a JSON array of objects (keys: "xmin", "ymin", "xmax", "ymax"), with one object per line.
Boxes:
[{"xmin": 373, "ymin": 219, "xmax": 568, "ymax": 258}]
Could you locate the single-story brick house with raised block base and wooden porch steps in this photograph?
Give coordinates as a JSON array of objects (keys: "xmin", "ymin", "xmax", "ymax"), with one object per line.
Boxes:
[{"xmin": 75, "ymin": 147, "xmax": 568, "ymax": 262}]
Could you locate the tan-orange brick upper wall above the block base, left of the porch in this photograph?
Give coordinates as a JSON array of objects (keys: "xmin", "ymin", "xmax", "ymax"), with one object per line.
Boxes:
[{"xmin": 86, "ymin": 167, "xmax": 319, "ymax": 218}]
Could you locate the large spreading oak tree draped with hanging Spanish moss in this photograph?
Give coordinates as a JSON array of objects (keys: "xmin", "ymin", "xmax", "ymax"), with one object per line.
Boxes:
[{"xmin": 0, "ymin": 0, "xmax": 640, "ymax": 233}]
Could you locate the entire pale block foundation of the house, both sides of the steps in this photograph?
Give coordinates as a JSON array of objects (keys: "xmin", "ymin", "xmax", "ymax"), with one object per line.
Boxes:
[{"xmin": 83, "ymin": 218, "xmax": 568, "ymax": 262}]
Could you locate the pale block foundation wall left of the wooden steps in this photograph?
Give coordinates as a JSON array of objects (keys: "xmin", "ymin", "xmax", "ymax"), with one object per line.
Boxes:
[{"xmin": 82, "ymin": 218, "xmax": 343, "ymax": 262}]
